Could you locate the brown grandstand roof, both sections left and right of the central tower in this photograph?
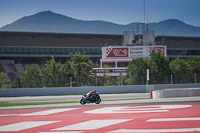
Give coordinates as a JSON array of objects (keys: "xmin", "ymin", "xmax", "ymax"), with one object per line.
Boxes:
[{"xmin": 0, "ymin": 31, "xmax": 200, "ymax": 49}]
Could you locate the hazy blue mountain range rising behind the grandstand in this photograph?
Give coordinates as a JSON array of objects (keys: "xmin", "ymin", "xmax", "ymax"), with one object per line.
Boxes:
[{"xmin": 0, "ymin": 11, "xmax": 200, "ymax": 37}]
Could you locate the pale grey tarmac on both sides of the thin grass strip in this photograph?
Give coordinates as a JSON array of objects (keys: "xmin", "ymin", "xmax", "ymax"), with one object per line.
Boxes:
[{"xmin": 0, "ymin": 93, "xmax": 200, "ymax": 110}]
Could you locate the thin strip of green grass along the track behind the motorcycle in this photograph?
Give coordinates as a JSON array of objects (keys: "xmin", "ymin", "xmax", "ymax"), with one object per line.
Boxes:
[{"xmin": 0, "ymin": 98, "xmax": 149, "ymax": 107}]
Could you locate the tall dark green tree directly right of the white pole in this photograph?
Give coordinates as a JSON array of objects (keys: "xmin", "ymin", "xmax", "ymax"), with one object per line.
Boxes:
[{"xmin": 149, "ymin": 53, "xmax": 170, "ymax": 83}]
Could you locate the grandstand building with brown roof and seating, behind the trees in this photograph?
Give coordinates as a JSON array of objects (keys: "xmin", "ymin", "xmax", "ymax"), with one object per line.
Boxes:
[{"xmin": 0, "ymin": 31, "xmax": 200, "ymax": 82}]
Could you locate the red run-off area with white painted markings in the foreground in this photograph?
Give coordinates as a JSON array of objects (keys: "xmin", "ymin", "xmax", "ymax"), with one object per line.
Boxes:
[{"xmin": 0, "ymin": 102, "xmax": 200, "ymax": 133}]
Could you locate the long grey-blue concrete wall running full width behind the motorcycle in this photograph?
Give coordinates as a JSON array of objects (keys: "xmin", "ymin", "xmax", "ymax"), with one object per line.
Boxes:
[{"xmin": 0, "ymin": 84, "xmax": 200, "ymax": 97}]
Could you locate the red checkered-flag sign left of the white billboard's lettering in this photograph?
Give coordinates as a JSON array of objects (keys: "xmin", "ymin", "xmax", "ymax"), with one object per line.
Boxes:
[{"xmin": 106, "ymin": 47, "xmax": 128, "ymax": 57}]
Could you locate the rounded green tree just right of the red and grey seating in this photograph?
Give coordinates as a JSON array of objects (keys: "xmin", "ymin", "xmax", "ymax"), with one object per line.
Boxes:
[{"xmin": 16, "ymin": 65, "xmax": 42, "ymax": 88}]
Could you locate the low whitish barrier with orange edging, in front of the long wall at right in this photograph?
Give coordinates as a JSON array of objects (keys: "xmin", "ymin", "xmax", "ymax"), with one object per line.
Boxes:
[{"xmin": 152, "ymin": 88, "xmax": 200, "ymax": 99}]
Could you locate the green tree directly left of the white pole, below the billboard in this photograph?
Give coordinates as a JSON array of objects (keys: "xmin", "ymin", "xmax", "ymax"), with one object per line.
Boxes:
[{"xmin": 125, "ymin": 58, "xmax": 148, "ymax": 84}]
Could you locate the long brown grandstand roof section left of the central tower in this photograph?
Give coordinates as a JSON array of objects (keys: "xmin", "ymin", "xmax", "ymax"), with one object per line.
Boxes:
[{"xmin": 0, "ymin": 31, "xmax": 122, "ymax": 47}]
